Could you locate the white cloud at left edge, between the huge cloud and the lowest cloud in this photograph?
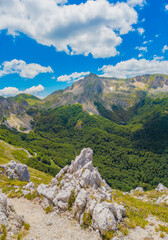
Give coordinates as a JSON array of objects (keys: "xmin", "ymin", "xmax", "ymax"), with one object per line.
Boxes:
[{"xmin": 0, "ymin": 59, "xmax": 53, "ymax": 79}]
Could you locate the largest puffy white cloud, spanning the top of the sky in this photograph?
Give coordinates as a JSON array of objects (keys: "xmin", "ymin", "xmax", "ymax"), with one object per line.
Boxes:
[{"xmin": 0, "ymin": 0, "xmax": 138, "ymax": 58}]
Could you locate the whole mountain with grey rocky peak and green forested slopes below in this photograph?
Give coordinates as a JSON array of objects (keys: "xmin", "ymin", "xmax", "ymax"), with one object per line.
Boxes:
[{"xmin": 0, "ymin": 74, "xmax": 168, "ymax": 191}]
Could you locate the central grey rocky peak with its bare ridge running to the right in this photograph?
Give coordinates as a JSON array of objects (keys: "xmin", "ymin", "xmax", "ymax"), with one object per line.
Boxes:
[{"xmin": 44, "ymin": 73, "xmax": 168, "ymax": 115}]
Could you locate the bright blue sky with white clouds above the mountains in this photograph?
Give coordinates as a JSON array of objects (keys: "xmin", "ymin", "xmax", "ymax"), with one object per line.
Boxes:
[{"xmin": 0, "ymin": 0, "xmax": 168, "ymax": 98}]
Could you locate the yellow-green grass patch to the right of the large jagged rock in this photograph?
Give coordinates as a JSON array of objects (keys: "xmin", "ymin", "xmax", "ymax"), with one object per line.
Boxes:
[{"xmin": 113, "ymin": 191, "xmax": 168, "ymax": 235}]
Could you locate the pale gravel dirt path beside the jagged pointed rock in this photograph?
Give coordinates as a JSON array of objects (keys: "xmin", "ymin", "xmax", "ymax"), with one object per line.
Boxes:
[{"xmin": 8, "ymin": 198, "xmax": 100, "ymax": 240}]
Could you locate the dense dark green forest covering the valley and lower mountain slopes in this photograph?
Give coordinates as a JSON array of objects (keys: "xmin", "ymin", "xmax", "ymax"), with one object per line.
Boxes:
[{"xmin": 0, "ymin": 95, "xmax": 168, "ymax": 191}]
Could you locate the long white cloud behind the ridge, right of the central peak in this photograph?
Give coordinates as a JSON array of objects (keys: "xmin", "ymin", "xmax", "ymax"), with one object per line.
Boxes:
[{"xmin": 99, "ymin": 58, "xmax": 168, "ymax": 78}]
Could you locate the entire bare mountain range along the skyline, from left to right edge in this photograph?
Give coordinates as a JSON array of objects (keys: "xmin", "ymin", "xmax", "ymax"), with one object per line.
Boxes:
[{"xmin": 0, "ymin": 73, "xmax": 168, "ymax": 122}]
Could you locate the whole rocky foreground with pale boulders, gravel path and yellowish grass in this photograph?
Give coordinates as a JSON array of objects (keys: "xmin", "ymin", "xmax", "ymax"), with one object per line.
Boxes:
[{"xmin": 0, "ymin": 148, "xmax": 168, "ymax": 240}]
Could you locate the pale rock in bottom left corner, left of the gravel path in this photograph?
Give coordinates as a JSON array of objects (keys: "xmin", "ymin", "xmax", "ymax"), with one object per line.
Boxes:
[{"xmin": 0, "ymin": 192, "xmax": 24, "ymax": 236}]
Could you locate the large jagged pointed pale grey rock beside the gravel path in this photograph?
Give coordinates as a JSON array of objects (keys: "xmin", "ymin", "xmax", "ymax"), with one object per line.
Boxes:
[{"xmin": 37, "ymin": 148, "xmax": 125, "ymax": 235}]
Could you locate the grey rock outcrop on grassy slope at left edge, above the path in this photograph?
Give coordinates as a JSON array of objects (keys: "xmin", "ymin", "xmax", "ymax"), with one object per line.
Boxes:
[{"xmin": 0, "ymin": 160, "xmax": 30, "ymax": 182}]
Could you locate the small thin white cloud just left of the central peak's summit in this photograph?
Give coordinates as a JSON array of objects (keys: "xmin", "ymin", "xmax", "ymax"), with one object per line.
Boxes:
[{"xmin": 57, "ymin": 72, "xmax": 90, "ymax": 82}]
